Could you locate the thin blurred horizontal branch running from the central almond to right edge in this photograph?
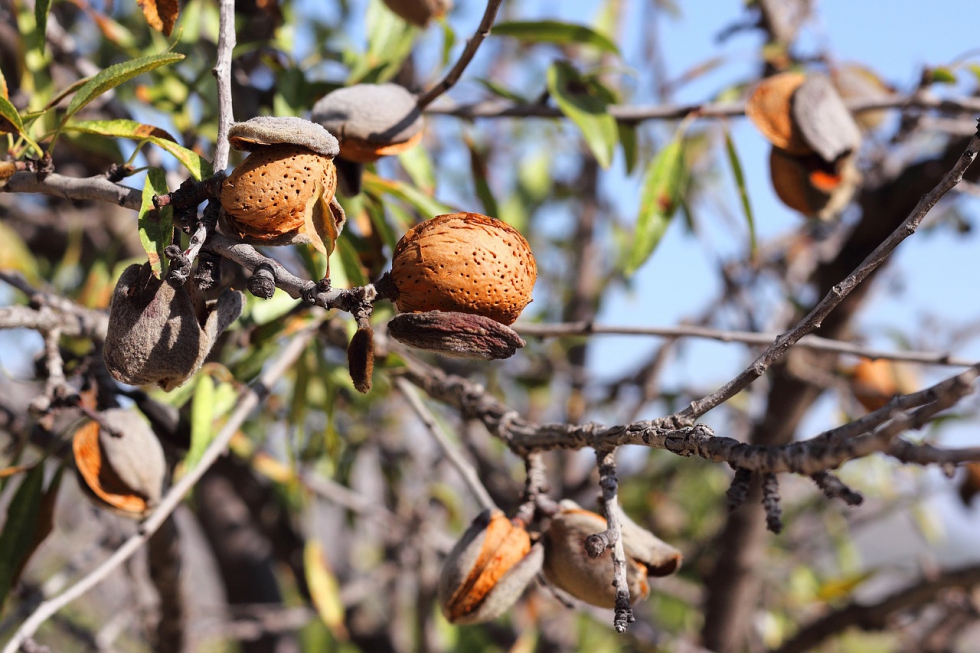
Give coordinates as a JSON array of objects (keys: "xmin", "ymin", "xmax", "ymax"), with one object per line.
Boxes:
[{"xmin": 513, "ymin": 322, "xmax": 976, "ymax": 367}]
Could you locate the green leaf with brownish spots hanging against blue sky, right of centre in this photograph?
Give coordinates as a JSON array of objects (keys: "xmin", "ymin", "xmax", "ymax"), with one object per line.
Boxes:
[{"xmin": 624, "ymin": 128, "xmax": 685, "ymax": 276}]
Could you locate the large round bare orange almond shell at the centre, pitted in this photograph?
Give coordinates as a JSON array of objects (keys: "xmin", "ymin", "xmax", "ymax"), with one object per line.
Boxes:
[{"xmin": 391, "ymin": 213, "xmax": 537, "ymax": 324}]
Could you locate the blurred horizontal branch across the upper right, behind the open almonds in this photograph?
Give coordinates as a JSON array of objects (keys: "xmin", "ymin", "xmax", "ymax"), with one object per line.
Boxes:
[{"xmin": 426, "ymin": 94, "xmax": 980, "ymax": 122}]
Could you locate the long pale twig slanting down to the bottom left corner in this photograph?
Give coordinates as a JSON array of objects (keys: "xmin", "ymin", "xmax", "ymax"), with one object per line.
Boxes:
[{"xmin": 3, "ymin": 321, "xmax": 319, "ymax": 653}]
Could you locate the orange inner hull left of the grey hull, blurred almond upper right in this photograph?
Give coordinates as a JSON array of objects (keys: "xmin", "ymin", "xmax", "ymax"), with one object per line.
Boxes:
[{"xmin": 745, "ymin": 73, "xmax": 813, "ymax": 154}]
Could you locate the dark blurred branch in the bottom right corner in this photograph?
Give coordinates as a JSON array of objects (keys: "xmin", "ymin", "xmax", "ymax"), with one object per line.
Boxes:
[{"xmin": 776, "ymin": 565, "xmax": 980, "ymax": 653}]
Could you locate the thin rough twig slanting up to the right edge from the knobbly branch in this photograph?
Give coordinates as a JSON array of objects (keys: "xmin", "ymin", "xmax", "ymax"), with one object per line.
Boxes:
[{"xmin": 675, "ymin": 135, "xmax": 980, "ymax": 425}]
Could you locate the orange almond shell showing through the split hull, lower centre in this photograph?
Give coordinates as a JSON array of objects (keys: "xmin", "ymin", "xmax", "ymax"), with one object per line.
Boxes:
[{"xmin": 444, "ymin": 511, "xmax": 531, "ymax": 621}]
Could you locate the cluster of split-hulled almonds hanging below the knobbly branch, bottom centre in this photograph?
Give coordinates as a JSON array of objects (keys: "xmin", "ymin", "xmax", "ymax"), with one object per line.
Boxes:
[{"xmin": 439, "ymin": 500, "xmax": 681, "ymax": 624}]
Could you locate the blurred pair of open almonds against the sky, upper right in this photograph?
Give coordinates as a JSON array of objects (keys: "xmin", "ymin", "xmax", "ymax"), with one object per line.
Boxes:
[{"xmin": 745, "ymin": 72, "xmax": 861, "ymax": 220}]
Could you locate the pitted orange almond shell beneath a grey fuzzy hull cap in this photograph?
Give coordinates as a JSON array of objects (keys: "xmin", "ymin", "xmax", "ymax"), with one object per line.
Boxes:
[{"xmin": 220, "ymin": 144, "xmax": 337, "ymax": 254}]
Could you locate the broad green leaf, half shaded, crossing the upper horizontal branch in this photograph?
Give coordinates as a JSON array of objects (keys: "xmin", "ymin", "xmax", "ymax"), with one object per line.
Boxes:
[{"xmin": 548, "ymin": 61, "xmax": 618, "ymax": 168}]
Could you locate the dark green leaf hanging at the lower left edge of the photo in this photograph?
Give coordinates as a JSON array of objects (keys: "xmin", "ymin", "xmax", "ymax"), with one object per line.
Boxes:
[{"xmin": 0, "ymin": 463, "xmax": 44, "ymax": 608}]
